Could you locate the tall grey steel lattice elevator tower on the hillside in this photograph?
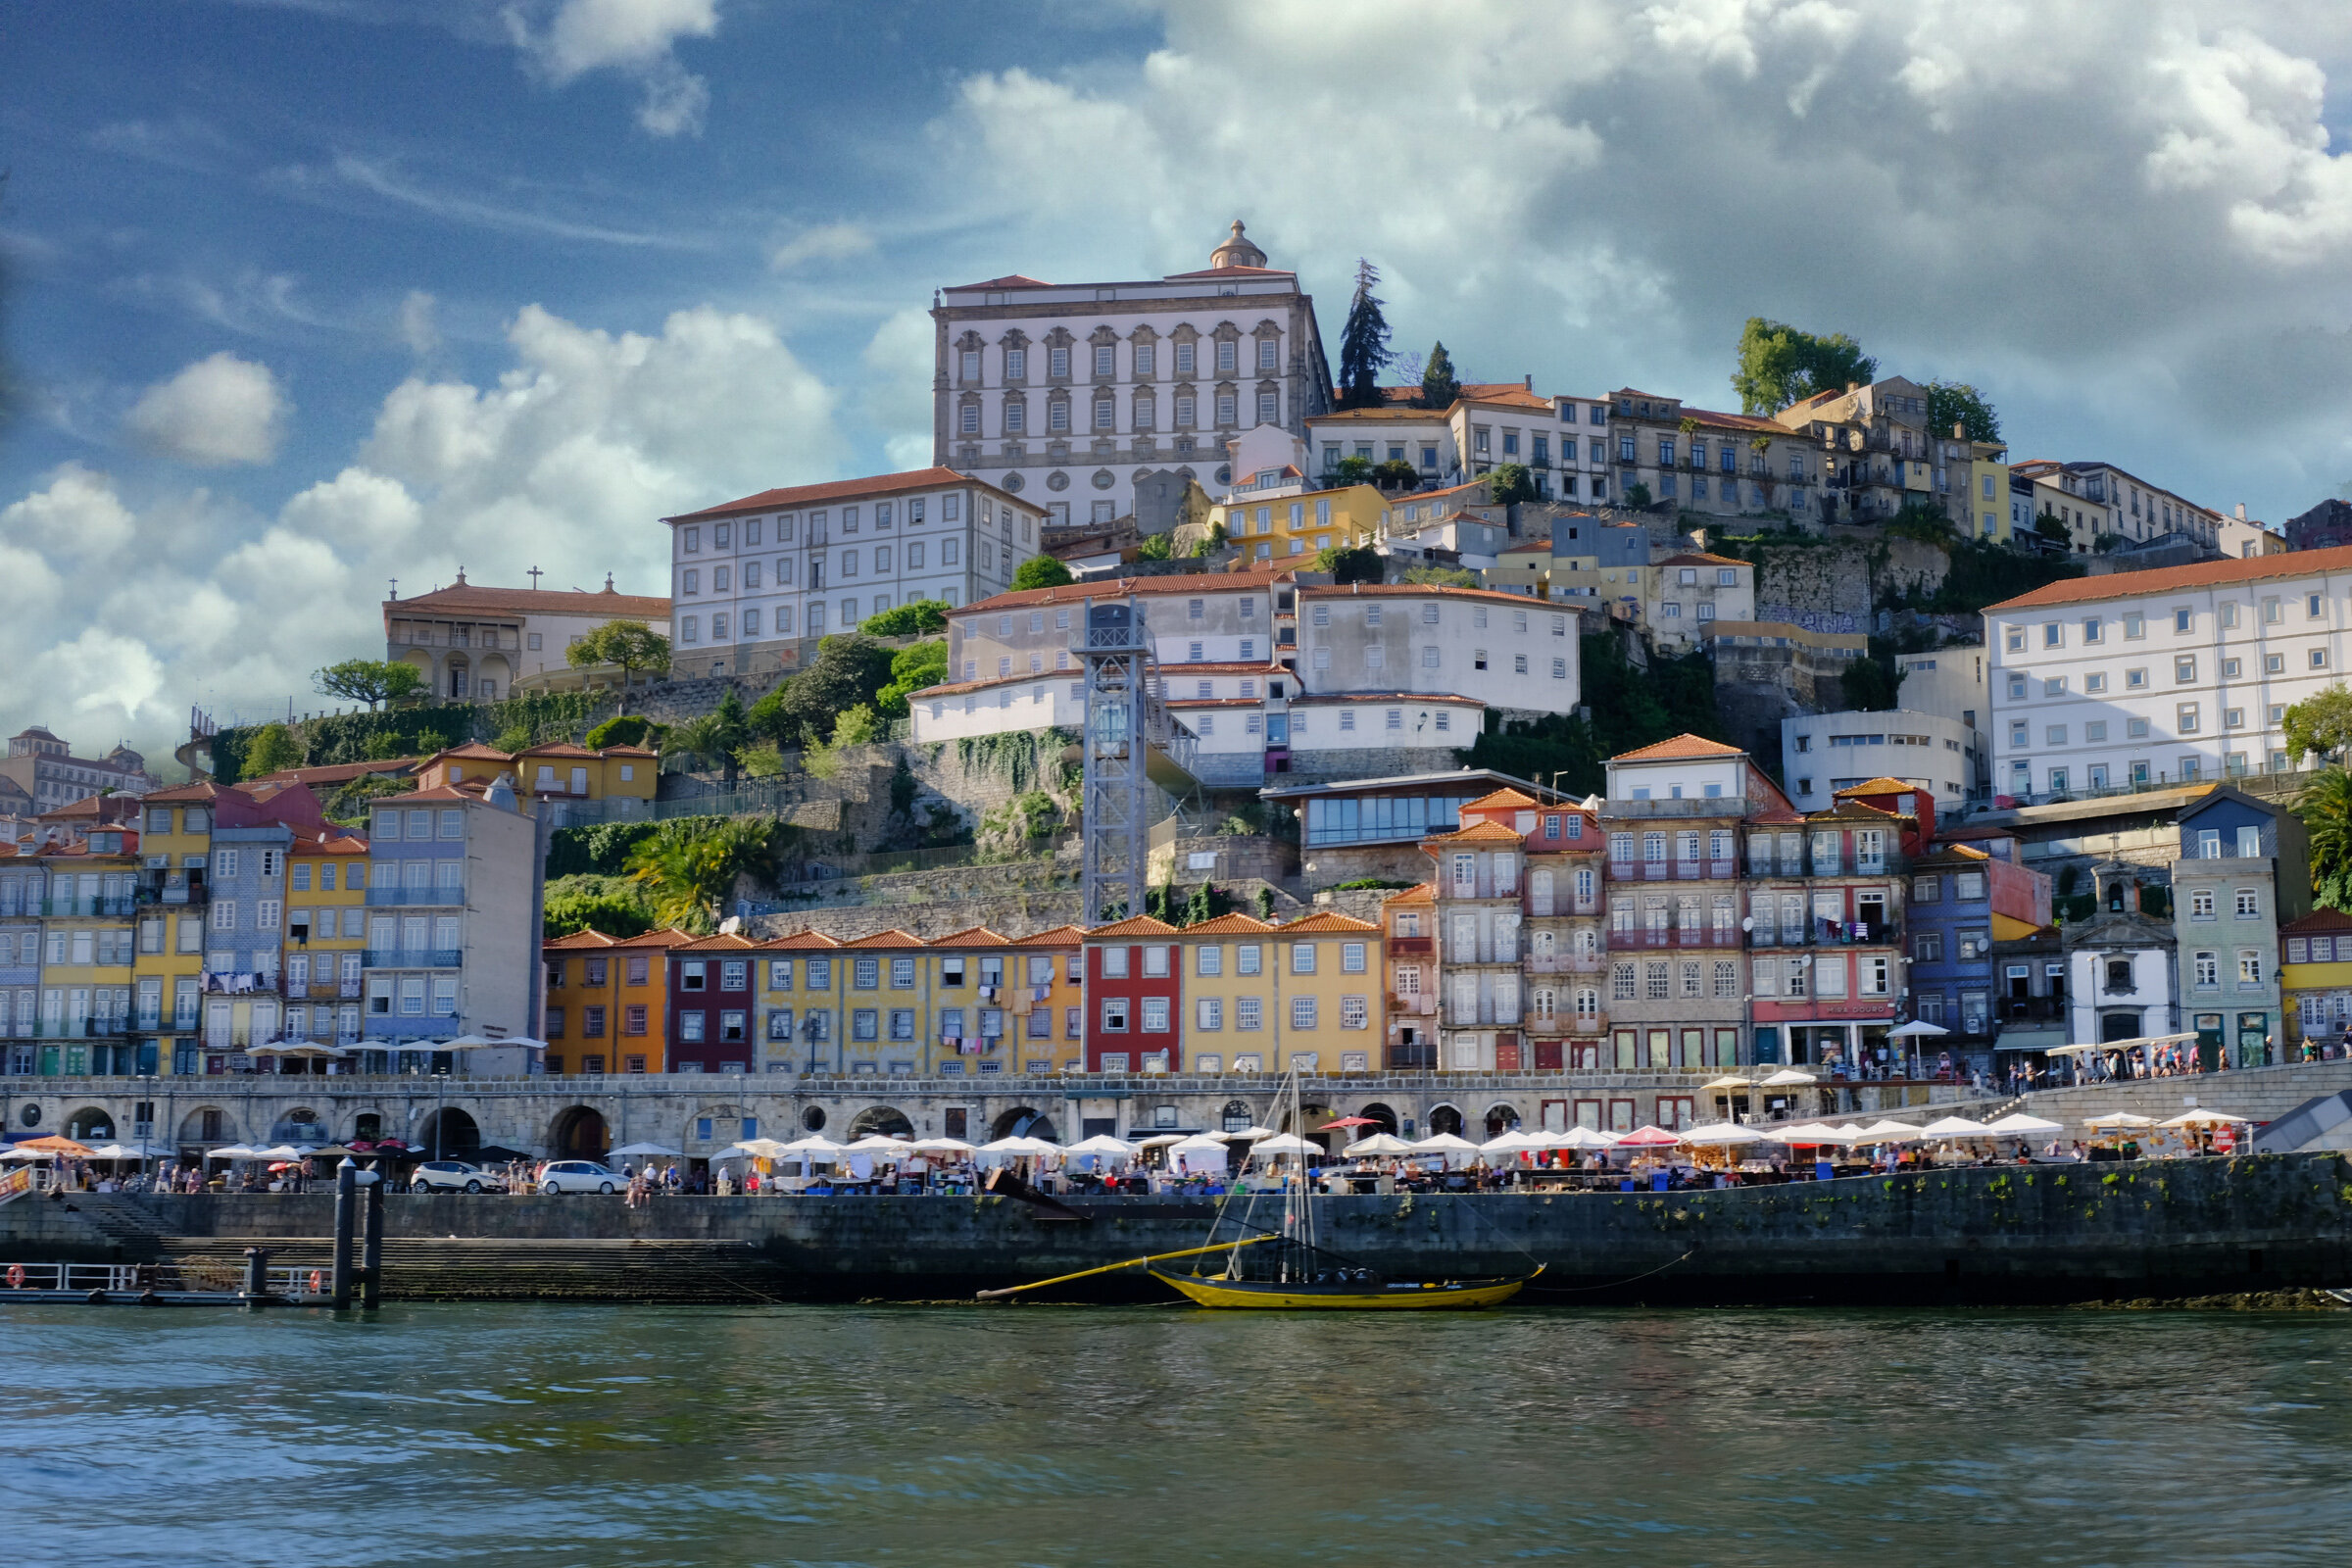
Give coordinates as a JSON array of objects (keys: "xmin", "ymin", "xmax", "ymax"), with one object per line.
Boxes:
[{"xmin": 1080, "ymin": 597, "xmax": 1152, "ymax": 926}]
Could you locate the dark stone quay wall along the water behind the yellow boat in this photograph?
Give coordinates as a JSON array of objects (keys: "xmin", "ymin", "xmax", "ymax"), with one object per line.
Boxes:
[{"xmin": 0, "ymin": 1152, "xmax": 2352, "ymax": 1304}]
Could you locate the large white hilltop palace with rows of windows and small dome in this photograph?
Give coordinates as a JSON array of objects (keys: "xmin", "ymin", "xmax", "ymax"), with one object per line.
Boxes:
[{"xmin": 931, "ymin": 219, "xmax": 1331, "ymax": 526}]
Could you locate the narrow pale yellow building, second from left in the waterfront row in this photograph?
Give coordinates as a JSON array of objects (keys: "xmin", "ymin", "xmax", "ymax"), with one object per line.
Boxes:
[{"xmin": 33, "ymin": 827, "xmax": 153, "ymax": 1077}]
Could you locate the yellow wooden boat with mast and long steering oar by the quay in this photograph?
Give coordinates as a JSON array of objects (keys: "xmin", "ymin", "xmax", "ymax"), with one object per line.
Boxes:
[{"xmin": 981, "ymin": 1074, "xmax": 1543, "ymax": 1312}]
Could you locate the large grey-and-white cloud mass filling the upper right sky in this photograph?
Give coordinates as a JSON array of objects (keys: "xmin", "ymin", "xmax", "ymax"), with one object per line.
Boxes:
[{"xmin": 931, "ymin": 0, "xmax": 2352, "ymax": 501}]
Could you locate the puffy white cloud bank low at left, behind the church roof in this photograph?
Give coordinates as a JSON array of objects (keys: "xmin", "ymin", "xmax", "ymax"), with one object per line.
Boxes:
[{"xmin": 0, "ymin": 306, "xmax": 847, "ymax": 757}]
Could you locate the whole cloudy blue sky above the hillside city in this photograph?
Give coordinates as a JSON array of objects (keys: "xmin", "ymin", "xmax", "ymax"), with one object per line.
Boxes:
[{"xmin": 0, "ymin": 0, "xmax": 2352, "ymax": 760}]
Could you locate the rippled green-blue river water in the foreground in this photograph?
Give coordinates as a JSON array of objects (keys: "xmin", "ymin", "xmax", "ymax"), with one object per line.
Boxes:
[{"xmin": 0, "ymin": 1304, "xmax": 2352, "ymax": 1568}]
